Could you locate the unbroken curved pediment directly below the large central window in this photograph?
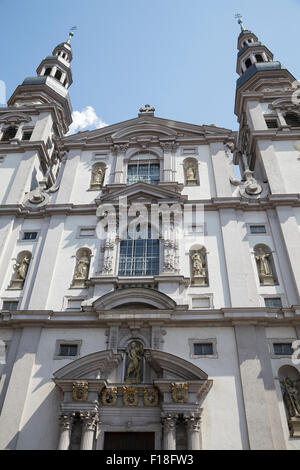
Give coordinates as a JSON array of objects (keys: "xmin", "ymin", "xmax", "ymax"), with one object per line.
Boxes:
[{"xmin": 93, "ymin": 287, "xmax": 176, "ymax": 311}]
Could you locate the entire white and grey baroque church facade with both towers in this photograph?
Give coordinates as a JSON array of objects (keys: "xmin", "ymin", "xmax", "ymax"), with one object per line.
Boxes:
[{"xmin": 0, "ymin": 24, "xmax": 300, "ymax": 450}]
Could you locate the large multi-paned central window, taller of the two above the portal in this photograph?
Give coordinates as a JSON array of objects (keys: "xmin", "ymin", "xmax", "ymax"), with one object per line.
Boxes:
[{"xmin": 119, "ymin": 226, "xmax": 159, "ymax": 276}]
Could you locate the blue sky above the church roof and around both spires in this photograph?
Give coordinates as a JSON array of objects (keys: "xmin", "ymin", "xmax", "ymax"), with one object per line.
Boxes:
[{"xmin": 0, "ymin": 0, "xmax": 300, "ymax": 129}]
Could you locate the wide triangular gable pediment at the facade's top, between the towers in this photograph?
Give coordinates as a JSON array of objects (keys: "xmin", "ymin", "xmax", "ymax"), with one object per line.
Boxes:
[{"xmin": 63, "ymin": 116, "xmax": 232, "ymax": 145}]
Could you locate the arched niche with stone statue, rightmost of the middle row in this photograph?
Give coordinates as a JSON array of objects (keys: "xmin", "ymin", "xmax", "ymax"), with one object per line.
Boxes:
[{"xmin": 254, "ymin": 244, "xmax": 278, "ymax": 286}]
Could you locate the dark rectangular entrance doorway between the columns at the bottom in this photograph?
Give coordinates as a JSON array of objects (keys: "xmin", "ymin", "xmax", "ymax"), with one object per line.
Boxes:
[{"xmin": 103, "ymin": 432, "xmax": 155, "ymax": 450}]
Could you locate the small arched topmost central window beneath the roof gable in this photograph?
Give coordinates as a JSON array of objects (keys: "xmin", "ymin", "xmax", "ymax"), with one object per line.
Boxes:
[{"xmin": 127, "ymin": 153, "xmax": 160, "ymax": 185}]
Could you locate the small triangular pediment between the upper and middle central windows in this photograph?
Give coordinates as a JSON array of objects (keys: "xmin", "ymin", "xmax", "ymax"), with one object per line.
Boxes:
[{"xmin": 96, "ymin": 182, "xmax": 186, "ymax": 204}]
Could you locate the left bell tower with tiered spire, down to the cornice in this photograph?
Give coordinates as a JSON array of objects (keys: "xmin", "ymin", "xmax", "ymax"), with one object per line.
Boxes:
[{"xmin": 0, "ymin": 32, "xmax": 74, "ymax": 204}]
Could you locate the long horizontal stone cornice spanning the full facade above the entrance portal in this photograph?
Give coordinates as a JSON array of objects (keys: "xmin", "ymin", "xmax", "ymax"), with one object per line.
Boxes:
[{"xmin": 0, "ymin": 305, "xmax": 300, "ymax": 328}]
